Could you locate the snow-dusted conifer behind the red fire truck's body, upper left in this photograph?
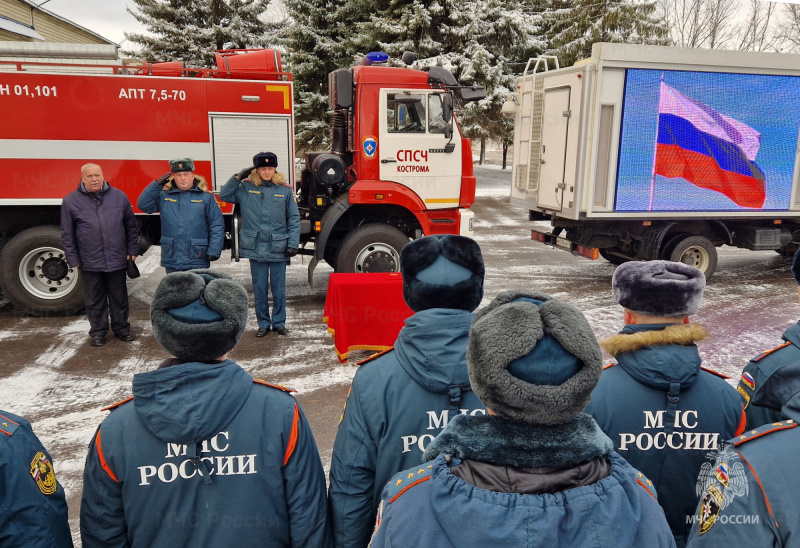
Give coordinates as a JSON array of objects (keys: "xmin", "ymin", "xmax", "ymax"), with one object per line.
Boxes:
[{"xmin": 123, "ymin": 0, "xmax": 268, "ymax": 67}]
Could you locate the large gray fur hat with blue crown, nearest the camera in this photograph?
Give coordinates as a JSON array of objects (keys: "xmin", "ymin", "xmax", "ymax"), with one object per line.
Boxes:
[{"xmin": 467, "ymin": 290, "xmax": 603, "ymax": 425}]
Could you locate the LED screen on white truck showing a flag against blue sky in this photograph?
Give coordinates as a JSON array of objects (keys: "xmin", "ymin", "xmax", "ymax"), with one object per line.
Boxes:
[{"xmin": 615, "ymin": 69, "xmax": 800, "ymax": 211}]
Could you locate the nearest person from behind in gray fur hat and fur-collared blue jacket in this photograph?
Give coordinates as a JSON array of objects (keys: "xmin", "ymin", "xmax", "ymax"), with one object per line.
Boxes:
[{"xmin": 371, "ymin": 291, "xmax": 675, "ymax": 548}]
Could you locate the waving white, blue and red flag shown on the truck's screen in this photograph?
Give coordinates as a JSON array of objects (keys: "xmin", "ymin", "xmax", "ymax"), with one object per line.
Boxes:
[{"xmin": 650, "ymin": 79, "xmax": 766, "ymax": 209}]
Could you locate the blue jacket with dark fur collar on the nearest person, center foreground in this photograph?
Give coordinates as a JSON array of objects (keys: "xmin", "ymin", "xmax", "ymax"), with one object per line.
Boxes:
[{"xmin": 371, "ymin": 415, "xmax": 675, "ymax": 548}]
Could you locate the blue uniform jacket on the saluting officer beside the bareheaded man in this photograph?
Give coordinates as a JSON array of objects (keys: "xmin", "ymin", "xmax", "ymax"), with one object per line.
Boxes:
[{"xmin": 136, "ymin": 176, "xmax": 225, "ymax": 270}]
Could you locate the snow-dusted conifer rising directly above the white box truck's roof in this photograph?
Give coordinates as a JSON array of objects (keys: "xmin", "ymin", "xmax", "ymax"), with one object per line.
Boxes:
[{"xmin": 546, "ymin": 0, "xmax": 667, "ymax": 66}]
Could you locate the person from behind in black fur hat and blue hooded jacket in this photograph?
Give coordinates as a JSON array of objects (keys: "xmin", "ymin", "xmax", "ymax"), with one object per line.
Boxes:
[{"xmin": 330, "ymin": 236, "xmax": 485, "ymax": 548}]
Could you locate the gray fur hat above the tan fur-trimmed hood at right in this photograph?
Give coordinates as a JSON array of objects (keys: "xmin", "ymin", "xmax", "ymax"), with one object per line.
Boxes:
[{"xmin": 611, "ymin": 261, "xmax": 706, "ymax": 318}]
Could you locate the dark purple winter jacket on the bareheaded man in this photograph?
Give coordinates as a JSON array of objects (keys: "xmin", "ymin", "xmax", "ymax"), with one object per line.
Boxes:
[{"xmin": 61, "ymin": 181, "xmax": 139, "ymax": 272}]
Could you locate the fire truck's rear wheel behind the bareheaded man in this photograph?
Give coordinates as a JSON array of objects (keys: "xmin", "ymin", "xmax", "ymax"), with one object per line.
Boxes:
[{"xmin": 0, "ymin": 226, "xmax": 83, "ymax": 316}]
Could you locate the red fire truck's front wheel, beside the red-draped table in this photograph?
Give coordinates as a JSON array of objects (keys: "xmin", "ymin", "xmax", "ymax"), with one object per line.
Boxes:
[{"xmin": 336, "ymin": 224, "xmax": 410, "ymax": 273}]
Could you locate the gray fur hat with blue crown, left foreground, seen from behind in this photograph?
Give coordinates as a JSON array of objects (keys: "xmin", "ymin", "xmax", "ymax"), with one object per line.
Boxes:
[{"xmin": 150, "ymin": 269, "xmax": 247, "ymax": 361}]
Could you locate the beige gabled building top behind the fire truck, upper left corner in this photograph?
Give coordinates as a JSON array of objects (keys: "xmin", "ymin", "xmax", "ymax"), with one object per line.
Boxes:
[{"xmin": 0, "ymin": 0, "xmax": 113, "ymax": 44}]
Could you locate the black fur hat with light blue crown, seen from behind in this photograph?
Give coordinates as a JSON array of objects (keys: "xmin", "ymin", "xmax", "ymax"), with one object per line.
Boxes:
[{"xmin": 400, "ymin": 234, "xmax": 484, "ymax": 312}]
